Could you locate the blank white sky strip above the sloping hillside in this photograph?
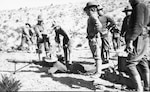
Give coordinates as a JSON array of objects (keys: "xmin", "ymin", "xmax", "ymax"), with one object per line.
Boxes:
[{"xmin": 0, "ymin": 0, "xmax": 90, "ymax": 10}]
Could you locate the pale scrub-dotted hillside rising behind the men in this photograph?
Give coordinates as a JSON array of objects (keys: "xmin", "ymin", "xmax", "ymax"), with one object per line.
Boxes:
[{"xmin": 0, "ymin": 0, "xmax": 131, "ymax": 50}]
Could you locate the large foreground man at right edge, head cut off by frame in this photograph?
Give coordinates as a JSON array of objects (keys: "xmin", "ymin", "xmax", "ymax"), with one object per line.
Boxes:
[{"xmin": 126, "ymin": 0, "xmax": 150, "ymax": 92}]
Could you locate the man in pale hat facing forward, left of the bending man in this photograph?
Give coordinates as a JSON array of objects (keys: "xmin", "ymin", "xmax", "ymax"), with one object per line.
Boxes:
[{"xmin": 34, "ymin": 15, "xmax": 50, "ymax": 58}]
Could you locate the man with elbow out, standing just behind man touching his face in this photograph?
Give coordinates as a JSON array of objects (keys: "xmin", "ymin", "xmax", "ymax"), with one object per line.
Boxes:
[{"xmin": 97, "ymin": 5, "xmax": 116, "ymax": 62}]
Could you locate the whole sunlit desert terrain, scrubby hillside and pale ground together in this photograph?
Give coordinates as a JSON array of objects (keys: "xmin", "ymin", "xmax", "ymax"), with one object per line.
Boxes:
[{"xmin": 0, "ymin": 0, "xmax": 148, "ymax": 92}]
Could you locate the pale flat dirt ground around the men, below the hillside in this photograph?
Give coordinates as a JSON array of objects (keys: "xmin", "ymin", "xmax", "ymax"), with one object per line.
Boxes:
[{"xmin": 0, "ymin": 41, "xmax": 131, "ymax": 91}]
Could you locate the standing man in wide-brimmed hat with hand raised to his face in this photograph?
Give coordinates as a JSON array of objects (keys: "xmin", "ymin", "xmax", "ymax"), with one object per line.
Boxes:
[{"xmin": 84, "ymin": 2, "xmax": 102, "ymax": 78}]
